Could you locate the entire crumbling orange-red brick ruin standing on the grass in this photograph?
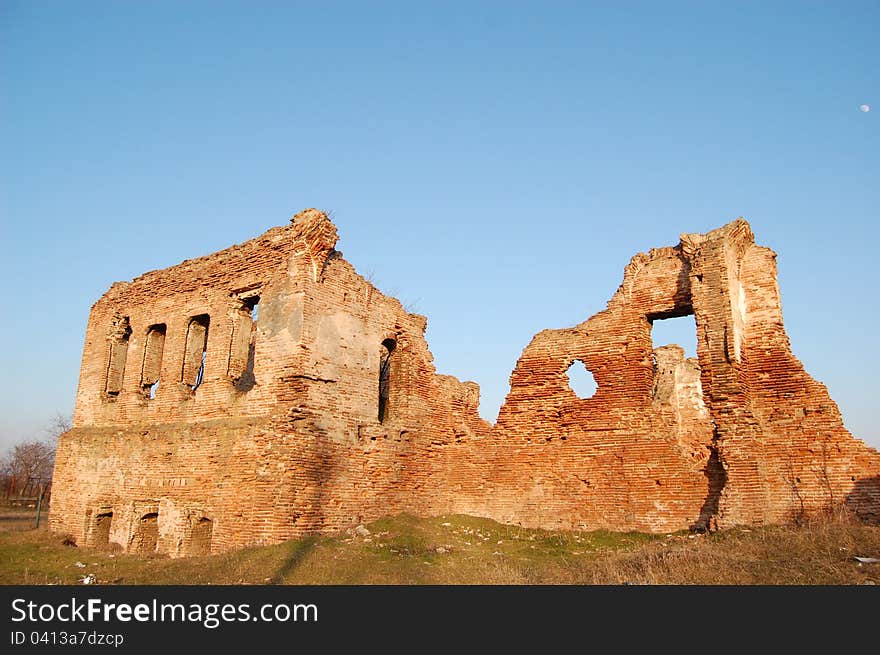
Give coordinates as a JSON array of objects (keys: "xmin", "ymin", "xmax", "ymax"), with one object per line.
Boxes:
[{"xmin": 50, "ymin": 209, "xmax": 880, "ymax": 556}]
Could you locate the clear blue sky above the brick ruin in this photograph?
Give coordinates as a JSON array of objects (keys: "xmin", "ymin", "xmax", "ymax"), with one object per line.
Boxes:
[{"xmin": 0, "ymin": 0, "xmax": 880, "ymax": 448}]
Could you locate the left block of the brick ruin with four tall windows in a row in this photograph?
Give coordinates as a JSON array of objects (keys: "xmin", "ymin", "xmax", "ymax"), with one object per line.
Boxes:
[{"xmin": 50, "ymin": 210, "xmax": 490, "ymax": 555}]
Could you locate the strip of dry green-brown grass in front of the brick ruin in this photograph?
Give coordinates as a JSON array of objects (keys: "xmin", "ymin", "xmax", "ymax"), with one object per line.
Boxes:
[{"xmin": 0, "ymin": 515, "xmax": 880, "ymax": 585}]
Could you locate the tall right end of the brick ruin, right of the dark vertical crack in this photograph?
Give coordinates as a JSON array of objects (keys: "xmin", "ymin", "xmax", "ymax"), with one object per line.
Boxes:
[{"xmin": 682, "ymin": 220, "xmax": 880, "ymax": 526}]
